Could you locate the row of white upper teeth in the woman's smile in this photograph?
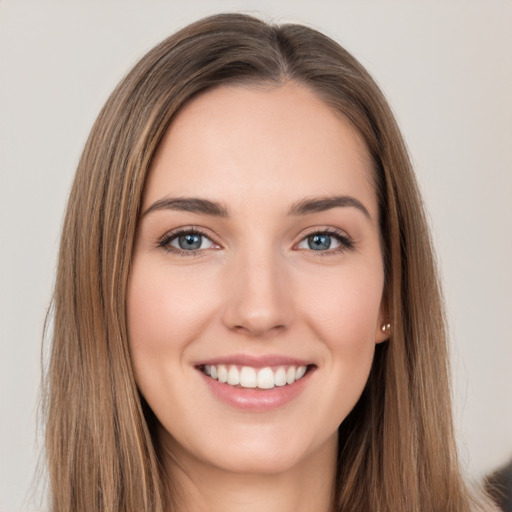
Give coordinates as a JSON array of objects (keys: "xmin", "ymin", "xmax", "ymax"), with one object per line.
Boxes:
[{"xmin": 203, "ymin": 364, "xmax": 307, "ymax": 389}]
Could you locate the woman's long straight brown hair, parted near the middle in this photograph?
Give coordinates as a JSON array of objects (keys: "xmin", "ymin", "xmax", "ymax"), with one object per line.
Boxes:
[{"xmin": 46, "ymin": 14, "xmax": 492, "ymax": 512}]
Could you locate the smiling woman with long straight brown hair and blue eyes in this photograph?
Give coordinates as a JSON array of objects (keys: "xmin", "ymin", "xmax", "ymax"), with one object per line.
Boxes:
[{"xmin": 46, "ymin": 14, "xmax": 496, "ymax": 512}]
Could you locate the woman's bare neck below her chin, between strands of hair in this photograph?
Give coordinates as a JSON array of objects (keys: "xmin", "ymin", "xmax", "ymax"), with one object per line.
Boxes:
[{"xmin": 159, "ymin": 430, "xmax": 337, "ymax": 512}]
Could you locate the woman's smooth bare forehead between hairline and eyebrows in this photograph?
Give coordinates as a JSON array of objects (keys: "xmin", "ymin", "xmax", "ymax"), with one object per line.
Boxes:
[{"xmin": 144, "ymin": 83, "xmax": 376, "ymax": 216}]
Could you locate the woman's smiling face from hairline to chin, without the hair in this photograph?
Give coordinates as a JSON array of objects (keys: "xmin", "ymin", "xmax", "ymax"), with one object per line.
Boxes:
[{"xmin": 127, "ymin": 83, "xmax": 385, "ymax": 473}]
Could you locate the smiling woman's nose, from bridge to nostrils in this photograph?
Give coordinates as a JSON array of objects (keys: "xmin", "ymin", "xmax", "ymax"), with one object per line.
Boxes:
[{"xmin": 222, "ymin": 250, "xmax": 293, "ymax": 338}]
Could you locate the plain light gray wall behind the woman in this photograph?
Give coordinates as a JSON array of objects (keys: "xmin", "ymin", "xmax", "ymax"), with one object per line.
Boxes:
[{"xmin": 0, "ymin": 0, "xmax": 512, "ymax": 512}]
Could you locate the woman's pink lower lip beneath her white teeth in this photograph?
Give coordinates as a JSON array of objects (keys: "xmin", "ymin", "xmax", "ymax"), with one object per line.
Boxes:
[{"xmin": 198, "ymin": 370, "xmax": 312, "ymax": 412}]
